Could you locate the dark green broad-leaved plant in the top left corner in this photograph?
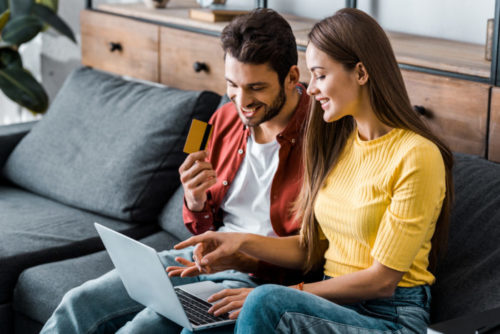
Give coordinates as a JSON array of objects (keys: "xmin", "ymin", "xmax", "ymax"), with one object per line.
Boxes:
[{"xmin": 0, "ymin": 0, "xmax": 76, "ymax": 113}]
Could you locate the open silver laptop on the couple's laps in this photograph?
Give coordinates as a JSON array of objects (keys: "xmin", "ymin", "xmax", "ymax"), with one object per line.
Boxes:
[{"xmin": 94, "ymin": 223, "xmax": 235, "ymax": 331}]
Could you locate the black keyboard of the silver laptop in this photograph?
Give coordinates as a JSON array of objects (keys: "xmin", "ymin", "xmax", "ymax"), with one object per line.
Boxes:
[{"xmin": 175, "ymin": 288, "xmax": 229, "ymax": 325}]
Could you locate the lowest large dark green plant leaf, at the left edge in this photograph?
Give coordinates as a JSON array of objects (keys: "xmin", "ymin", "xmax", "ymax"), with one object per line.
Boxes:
[{"xmin": 0, "ymin": 67, "xmax": 49, "ymax": 113}]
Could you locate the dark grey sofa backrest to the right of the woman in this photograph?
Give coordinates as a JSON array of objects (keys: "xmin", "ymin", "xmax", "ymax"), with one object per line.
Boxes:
[{"xmin": 432, "ymin": 154, "xmax": 500, "ymax": 322}]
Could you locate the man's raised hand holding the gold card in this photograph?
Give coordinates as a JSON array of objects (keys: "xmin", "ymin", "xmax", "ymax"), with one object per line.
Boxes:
[{"xmin": 179, "ymin": 151, "xmax": 217, "ymax": 211}]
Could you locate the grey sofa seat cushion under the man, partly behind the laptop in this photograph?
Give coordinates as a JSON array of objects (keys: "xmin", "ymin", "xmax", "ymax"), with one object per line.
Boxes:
[{"xmin": 13, "ymin": 231, "xmax": 179, "ymax": 326}]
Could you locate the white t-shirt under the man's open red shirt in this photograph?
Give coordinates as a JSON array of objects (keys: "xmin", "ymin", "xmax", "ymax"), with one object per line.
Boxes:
[{"xmin": 219, "ymin": 135, "xmax": 280, "ymax": 236}]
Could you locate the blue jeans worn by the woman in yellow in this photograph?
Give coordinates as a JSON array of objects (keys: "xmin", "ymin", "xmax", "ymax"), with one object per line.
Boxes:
[{"xmin": 235, "ymin": 284, "xmax": 430, "ymax": 334}]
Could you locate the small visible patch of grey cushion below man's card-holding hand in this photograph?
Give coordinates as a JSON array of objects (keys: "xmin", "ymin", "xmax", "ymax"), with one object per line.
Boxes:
[{"xmin": 159, "ymin": 185, "xmax": 192, "ymax": 240}]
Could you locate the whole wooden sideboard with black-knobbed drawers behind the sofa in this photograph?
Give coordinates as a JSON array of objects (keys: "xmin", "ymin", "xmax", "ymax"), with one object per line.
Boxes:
[{"xmin": 81, "ymin": 0, "xmax": 500, "ymax": 161}]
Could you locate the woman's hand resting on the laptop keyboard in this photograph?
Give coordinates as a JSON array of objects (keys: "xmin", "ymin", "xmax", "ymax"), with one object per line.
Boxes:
[{"xmin": 207, "ymin": 288, "xmax": 253, "ymax": 319}]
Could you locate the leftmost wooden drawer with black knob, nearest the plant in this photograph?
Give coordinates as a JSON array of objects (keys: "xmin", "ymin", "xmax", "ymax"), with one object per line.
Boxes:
[{"xmin": 80, "ymin": 10, "xmax": 159, "ymax": 82}]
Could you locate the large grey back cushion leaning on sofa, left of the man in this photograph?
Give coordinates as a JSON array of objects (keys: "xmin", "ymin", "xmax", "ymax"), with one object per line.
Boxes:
[{"xmin": 3, "ymin": 68, "xmax": 220, "ymax": 222}]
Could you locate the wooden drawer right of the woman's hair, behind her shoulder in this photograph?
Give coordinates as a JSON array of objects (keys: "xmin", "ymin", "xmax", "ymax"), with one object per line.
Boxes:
[{"xmin": 402, "ymin": 70, "xmax": 490, "ymax": 157}]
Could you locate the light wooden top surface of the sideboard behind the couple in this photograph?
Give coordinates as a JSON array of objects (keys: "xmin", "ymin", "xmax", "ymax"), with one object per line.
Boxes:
[{"xmin": 97, "ymin": 0, "xmax": 491, "ymax": 78}]
